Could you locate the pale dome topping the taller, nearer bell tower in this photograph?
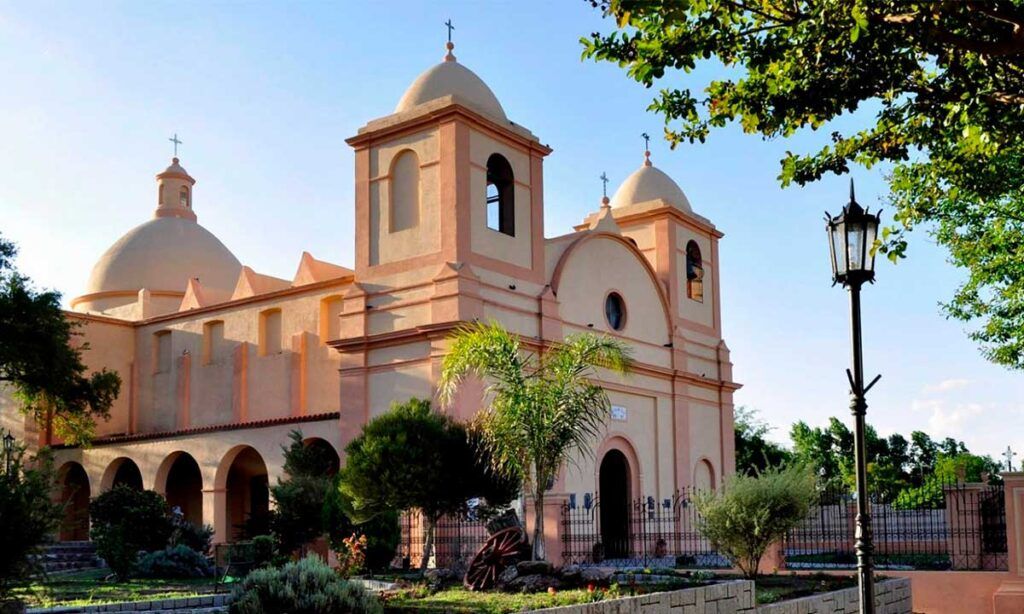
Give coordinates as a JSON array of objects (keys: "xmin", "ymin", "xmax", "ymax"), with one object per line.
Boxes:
[{"xmin": 394, "ymin": 53, "xmax": 508, "ymax": 121}]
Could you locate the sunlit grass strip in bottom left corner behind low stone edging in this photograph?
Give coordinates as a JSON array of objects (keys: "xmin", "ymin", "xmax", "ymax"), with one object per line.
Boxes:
[{"xmin": 14, "ymin": 569, "xmax": 224, "ymax": 608}]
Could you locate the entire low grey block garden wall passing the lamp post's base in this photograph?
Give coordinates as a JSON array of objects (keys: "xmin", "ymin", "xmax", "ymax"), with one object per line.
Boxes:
[{"xmin": 538, "ymin": 578, "xmax": 912, "ymax": 614}]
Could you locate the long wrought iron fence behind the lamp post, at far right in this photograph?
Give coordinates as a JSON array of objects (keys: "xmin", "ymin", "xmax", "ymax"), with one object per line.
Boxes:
[{"xmin": 783, "ymin": 482, "xmax": 1008, "ymax": 570}]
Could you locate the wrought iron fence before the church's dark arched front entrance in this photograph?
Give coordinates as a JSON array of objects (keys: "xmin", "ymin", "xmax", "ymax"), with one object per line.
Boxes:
[{"xmin": 561, "ymin": 488, "xmax": 729, "ymax": 567}]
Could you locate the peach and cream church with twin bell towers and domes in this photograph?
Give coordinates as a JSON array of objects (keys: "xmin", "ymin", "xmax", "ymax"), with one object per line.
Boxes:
[{"xmin": 2, "ymin": 38, "xmax": 738, "ymax": 552}]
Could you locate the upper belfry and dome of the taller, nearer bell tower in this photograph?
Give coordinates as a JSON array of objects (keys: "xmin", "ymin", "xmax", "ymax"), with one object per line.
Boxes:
[{"xmin": 347, "ymin": 42, "xmax": 551, "ymax": 294}]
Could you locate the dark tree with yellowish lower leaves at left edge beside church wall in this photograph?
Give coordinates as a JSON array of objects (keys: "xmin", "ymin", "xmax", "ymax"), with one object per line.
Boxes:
[{"xmin": 0, "ymin": 232, "xmax": 121, "ymax": 444}]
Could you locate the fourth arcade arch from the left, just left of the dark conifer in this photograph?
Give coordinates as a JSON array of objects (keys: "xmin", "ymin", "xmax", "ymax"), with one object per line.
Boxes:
[{"xmin": 226, "ymin": 446, "xmax": 270, "ymax": 541}]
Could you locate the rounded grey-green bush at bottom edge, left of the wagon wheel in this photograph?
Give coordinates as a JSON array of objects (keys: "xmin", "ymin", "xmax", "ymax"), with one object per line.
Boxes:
[{"xmin": 230, "ymin": 557, "xmax": 384, "ymax": 614}]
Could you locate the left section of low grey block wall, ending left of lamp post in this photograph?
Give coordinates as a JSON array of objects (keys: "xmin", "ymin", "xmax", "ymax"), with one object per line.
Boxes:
[{"xmin": 539, "ymin": 580, "xmax": 753, "ymax": 614}]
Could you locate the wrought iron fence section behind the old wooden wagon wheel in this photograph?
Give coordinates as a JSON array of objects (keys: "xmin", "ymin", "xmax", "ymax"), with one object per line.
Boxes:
[{"xmin": 394, "ymin": 512, "xmax": 489, "ymax": 569}]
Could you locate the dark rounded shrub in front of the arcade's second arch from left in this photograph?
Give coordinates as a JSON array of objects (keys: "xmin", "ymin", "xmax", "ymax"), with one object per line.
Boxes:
[{"xmin": 89, "ymin": 485, "xmax": 173, "ymax": 581}]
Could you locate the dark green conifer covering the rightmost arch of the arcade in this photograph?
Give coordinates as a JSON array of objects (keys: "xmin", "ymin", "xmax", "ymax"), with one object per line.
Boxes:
[{"xmin": 270, "ymin": 431, "xmax": 337, "ymax": 554}]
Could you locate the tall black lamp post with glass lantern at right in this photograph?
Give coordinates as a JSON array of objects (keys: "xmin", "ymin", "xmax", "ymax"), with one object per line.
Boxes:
[{"xmin": 825, "ymin": 179, "xmax": 882, "ymax": 614}]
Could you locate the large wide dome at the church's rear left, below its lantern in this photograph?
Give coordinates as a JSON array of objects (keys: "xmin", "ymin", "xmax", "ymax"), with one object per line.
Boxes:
[{"xmin": 85, "ymin": 217, "xmax": 242, "ymax": 295}]
